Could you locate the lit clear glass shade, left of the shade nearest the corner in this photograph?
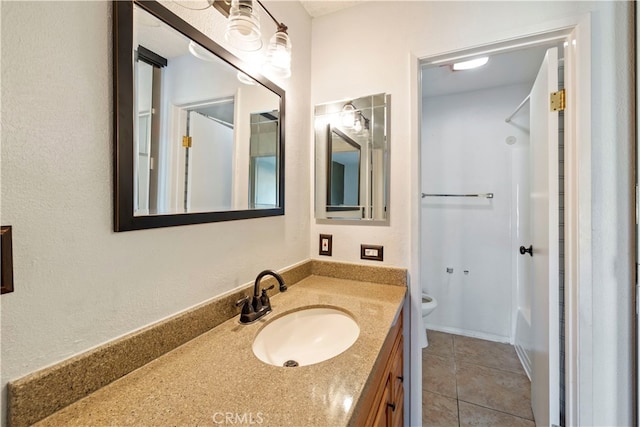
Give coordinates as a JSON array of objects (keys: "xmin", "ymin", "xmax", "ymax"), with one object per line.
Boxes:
[{"xmin": 224, "ymin": 0, "xmax": 262, "ymax": 52}]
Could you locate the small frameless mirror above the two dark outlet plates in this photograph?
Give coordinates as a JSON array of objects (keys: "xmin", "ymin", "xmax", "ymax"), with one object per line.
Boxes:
[{"xmin": 315, "ymin": 93, "xmax": 390, "ymax": 223}]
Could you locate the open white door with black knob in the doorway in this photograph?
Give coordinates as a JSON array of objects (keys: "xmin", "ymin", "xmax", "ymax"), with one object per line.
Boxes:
[{"xmin": 525, "ymin": 48, "xmax": 560, "ymax": 426}]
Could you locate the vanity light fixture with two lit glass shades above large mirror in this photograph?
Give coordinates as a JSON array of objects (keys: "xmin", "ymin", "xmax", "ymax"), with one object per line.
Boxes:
[{"xmin": 208, "ymin": 0, "xmax": 291, "ymax": 78}]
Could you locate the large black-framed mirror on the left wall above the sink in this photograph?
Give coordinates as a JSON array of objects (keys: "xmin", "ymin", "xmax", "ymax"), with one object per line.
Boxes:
[{"xmin": 113, "ymin": 1, "xmax": 285, "ymax": 231}]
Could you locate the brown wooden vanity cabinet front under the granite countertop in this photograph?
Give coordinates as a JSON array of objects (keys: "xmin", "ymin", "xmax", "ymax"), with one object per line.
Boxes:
[{"xmin": 351, "ymin": 311, "xmax": 404, "ymax": 427}]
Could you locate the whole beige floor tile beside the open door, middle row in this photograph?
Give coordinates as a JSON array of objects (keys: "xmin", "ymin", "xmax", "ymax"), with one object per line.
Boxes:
[{"xmin": 456, "ymin": 363, "xmax": 533, "ymax": 420}]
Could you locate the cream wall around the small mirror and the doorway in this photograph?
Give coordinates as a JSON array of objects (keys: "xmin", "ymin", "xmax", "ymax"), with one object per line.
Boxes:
[{"xmin": 309, "ymin": 1, "xmax": 633, "ymax": 425}]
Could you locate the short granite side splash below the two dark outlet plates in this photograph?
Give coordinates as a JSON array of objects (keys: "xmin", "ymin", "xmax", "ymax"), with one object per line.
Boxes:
[{"xmin": 311, "ymin": 260, "xmax": 407, "ymax": 286}]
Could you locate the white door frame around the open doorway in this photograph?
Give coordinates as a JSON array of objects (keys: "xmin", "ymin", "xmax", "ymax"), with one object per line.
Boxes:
[{"xmin": 406, "ymin": 13, "xmax": 593, "ymax": 425}]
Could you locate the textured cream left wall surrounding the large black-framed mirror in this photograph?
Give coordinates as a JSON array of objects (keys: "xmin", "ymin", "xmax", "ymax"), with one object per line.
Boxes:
[{"xmin": 0, "ymin": 1, "xmax": 311, "ymax": 422}]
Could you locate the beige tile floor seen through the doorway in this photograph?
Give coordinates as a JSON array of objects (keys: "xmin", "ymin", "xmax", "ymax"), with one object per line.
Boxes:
[{"xmin": 422, "ymin": 331, "xmax": 535, "ymax": 427}]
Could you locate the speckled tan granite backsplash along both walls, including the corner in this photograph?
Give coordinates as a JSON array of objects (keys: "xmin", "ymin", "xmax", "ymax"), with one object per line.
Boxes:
[{"xmin": 7, "ymin": 260, "xmax": 407, "ymax": 426}]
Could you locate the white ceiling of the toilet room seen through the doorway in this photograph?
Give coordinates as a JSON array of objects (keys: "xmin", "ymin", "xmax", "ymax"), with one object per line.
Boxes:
[{"xmin": 422, "ymin": 46, "xmax": 550, "ymax": 97}]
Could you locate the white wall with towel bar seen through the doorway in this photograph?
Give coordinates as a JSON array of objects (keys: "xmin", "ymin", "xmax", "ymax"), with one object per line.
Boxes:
[{"xmin": 421, "ymin": 83, "xmax": 531, "ymax": 342}]
